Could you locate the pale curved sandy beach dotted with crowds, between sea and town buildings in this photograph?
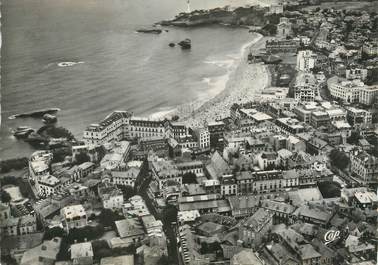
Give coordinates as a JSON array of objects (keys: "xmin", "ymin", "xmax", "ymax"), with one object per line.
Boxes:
[{"xmin": 175, "ymin": 36, "xmax": 270, "ymax": 127}]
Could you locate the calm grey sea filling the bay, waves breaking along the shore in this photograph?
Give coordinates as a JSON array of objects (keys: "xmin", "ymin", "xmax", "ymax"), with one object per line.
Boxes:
[{"xmin": 0, "ymin": 0, "xmax": 256, "ymax": 159}]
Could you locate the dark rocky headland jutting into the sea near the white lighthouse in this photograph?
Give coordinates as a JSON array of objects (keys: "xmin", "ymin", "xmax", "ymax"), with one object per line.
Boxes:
[{"xmin": 157, "ymin": 6, "xmax": 269, "ymax": 27}]
